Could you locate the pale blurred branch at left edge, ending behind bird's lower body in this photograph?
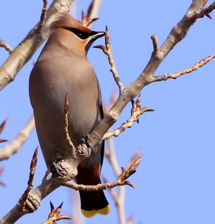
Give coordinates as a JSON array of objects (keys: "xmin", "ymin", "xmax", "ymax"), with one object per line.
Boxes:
[{"xmin": 0, "ymin": 116, "xmax": 35, "ymax": 161}]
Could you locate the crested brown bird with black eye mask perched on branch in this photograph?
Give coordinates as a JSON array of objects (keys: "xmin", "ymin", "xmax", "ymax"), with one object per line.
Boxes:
[{"xmin": 29, "ymin": 14, "xmax": 110, "ymax": 217}]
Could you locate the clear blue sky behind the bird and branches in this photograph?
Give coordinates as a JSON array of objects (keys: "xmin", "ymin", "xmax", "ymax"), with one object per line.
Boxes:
[{"xmin": 0, "ymin": 0, "xmax": 215, "ymax": 224}]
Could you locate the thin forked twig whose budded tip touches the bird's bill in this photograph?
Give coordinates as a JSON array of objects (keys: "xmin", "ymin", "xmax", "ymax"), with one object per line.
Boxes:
[{"xmin": 95, "ymin": 27, "xmax": 124, "ymax": 94}]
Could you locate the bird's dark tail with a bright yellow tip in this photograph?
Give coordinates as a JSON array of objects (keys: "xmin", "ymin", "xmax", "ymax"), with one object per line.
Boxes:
[{"xmin": 76, "ymin": 167, "xmax": 110, "ymax": 218}]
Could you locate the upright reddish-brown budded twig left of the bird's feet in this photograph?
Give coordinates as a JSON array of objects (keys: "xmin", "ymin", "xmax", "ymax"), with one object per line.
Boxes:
[{"xmin": 19, "ymin": 147, "xmax": 38, "ymax": 211}]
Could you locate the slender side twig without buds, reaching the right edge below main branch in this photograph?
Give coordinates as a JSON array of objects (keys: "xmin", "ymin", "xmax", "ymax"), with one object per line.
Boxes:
[{"xmin": 154, "ymin": 55, "xmax": 215, "ymax": 82}]
